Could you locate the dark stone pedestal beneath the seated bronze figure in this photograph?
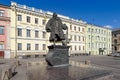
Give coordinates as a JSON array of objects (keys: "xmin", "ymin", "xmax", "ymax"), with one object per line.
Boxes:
[{"xmin": 46, "ymin": 45, "xmax": 70, "ymax": 66}]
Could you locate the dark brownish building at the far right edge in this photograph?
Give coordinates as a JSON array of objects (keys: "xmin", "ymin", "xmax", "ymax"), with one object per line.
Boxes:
[{"xmin": 112, "ymin": 29, "xmax": 120, "ymax": 52}]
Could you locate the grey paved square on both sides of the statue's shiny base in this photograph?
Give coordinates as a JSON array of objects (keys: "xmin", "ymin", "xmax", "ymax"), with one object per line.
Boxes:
[{"xmin": 0, "ymin": 56, "xmax": 120, "ymax": 80}]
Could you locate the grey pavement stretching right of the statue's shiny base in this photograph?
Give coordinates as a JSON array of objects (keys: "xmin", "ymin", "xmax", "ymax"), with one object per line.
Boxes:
[{"xmin": 71, "ymin": 56, "xmax": 120, "ymax": 80}]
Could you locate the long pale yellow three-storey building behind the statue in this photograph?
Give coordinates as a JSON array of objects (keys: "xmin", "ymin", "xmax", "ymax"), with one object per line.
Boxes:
[{"xmin": 10, "ymin": 2, "xmax": 86, "ymax": 57}]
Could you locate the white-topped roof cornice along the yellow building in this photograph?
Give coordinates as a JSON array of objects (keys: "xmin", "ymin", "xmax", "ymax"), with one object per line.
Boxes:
[{"xmin": 11, "ymin": 2, "xmax": 86, "ymax": 27}]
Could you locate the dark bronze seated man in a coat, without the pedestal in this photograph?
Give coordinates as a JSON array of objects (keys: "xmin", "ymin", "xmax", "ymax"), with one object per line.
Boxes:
[{"xmin": 46, "ymin": 13, "xmax": 67, "ymax": 45}]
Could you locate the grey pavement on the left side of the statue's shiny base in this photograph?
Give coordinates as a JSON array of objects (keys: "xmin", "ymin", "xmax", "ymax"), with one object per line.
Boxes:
[{"xmin": 0, "ymin": 58, "xmax": 44, "ymax": 80}]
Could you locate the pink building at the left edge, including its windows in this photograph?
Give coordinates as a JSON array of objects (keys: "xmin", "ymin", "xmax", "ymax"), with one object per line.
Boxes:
[{"xmin": 0, "ymin": 5, "xmax": 10, "ymax": 58}]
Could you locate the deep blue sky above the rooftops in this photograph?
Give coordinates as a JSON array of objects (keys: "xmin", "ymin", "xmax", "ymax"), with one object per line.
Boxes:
[{"xmin": 0, "ymin": 0, "xmax": 120, "ymax": 29}]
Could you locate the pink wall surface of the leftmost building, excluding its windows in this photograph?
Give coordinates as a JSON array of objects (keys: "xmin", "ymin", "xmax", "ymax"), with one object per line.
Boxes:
[{"xmin": 0, "ymin": 5, "xmax": 10, "ymax": 49}]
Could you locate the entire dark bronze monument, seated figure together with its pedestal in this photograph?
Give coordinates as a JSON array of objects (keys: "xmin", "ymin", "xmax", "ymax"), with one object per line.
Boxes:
[{"xmin": 45, "ymin": 13, "xmax": 70, "ymax": 67}]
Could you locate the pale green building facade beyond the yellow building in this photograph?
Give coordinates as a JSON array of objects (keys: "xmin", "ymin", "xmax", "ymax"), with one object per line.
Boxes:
[{"xmin": 86, "ymin": 24, "xmax": 112, "ymax": 55}]
